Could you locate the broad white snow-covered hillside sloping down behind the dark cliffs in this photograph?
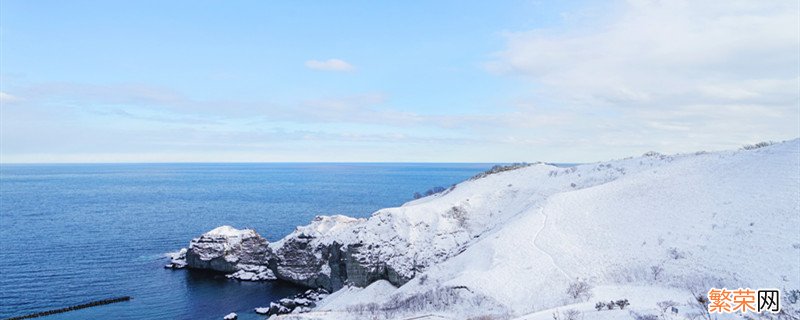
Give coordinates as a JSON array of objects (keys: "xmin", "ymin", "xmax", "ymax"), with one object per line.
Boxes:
[{"xmin": 272, "ymin": 140, "xmax": 800, "ymax": 319}]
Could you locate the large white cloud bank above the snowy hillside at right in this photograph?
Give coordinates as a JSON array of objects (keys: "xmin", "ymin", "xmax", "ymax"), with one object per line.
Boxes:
[{"xmin": 487, "ymin": 0, "xmax": 800, "ymax": 151}]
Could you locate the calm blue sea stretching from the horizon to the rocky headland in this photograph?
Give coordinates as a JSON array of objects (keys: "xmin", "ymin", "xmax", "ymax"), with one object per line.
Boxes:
[{"xmin": 0, "ymin": 163, "xmax": 490, "ymax": 319}]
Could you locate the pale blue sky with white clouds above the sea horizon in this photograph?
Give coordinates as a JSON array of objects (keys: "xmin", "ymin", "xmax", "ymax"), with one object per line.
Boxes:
[{"xmin": 0, "ymin": 0, "xmax": 800, "ymax": 163}]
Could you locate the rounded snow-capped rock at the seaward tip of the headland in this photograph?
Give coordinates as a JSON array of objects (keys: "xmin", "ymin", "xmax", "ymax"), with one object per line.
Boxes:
[{"xmin": 186, "ymin": 226, "xmax": 271, "ymax": 273}]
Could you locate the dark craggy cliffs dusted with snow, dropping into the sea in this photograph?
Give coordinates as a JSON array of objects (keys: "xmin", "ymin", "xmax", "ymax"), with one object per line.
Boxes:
[{"xmin": 172, "ymin": 216, "xmax": 422, "ymax": 291}]
